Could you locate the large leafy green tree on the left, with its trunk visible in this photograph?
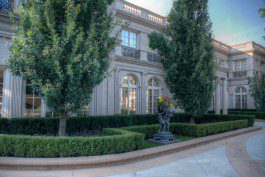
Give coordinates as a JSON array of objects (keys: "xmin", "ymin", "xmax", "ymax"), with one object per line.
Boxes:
[{"xmin": 8, "ymin": 0, "xmax": 117, "ymax": 136}]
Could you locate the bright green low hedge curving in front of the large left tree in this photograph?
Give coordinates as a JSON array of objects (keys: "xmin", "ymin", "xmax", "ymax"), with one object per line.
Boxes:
[{"xmin": 0, "ymin": 129, "xmax": 144, "ymax": 158}]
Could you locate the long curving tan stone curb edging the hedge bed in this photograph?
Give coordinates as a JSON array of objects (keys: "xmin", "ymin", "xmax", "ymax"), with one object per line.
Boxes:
[{"xmin": 0, "ymin": 127, "xmax": 262, "ymax": 170}]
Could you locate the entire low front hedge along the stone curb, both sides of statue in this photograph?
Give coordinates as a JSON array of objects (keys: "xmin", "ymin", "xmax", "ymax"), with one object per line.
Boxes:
[{"xmin": 0, "ymin": 120, "xmax": 248, "ymax": 158}]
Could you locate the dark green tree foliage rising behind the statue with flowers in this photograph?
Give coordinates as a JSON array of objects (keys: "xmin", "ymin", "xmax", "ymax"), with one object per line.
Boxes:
[{"xmin": 149, "ymin": 0, "xmax": 214, "ymax": 116}]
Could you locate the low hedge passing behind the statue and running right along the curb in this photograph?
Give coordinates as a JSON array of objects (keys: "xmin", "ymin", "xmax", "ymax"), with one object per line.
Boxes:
[{"xmin": 122, "ymin": 120, "xmax": 248, "ymax": 139}]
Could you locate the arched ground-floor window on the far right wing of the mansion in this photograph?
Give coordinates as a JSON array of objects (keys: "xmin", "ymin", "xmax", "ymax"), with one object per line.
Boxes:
[{"xmin": 235, "ymin": 87, "xmax": 248, "ymax": 109}]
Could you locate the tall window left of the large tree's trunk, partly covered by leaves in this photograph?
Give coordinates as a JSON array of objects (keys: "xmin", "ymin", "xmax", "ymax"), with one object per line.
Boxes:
[{"xmin": 25, "ymin": 84, "xmax": 41, "ymax": 117}]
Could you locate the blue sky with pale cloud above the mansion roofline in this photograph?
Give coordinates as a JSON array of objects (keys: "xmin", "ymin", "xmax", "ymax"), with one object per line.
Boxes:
[{"xmin": 126, "ymin": 0, "xmax": 265, "ymax": 46}]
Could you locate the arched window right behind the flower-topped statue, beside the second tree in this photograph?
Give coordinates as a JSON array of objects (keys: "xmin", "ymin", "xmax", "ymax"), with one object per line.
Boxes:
[{"xmin": 146, "ymin": 78, "xmax": 161, "ymax": 114}]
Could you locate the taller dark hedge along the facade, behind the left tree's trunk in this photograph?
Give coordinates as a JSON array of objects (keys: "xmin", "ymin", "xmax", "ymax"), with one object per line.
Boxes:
[{"xmin": 0, "ymin": 113, "xmax": 190, "ymax": 135}]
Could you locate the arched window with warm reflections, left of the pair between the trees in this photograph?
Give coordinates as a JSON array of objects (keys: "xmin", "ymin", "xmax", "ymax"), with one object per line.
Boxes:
[{"xmin": 120, "ymin": 74, "xmax": 138, "ymax": 114}]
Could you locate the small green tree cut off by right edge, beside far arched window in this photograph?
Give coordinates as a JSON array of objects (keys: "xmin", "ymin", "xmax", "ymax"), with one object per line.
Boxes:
[{"xmin": 250, "ymin": 73, "xmax": 265, "ymax": 111}]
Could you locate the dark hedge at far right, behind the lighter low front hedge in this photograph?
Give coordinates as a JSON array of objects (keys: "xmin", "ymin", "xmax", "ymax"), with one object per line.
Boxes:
[{"xmin": 196, "ymin": 114, "xmax": 255, "ymax": 127}]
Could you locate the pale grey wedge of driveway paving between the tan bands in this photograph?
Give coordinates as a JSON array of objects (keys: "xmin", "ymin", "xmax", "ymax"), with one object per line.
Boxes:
[{"xmin": 106, "ymin": 146, "xmax": 240, "ymax": 177}]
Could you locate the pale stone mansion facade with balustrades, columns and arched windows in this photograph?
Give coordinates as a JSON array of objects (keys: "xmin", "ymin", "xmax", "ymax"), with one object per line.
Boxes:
[{"xmin": 0, "ymin": 0, "xmax": 265, "ymax": 117}]
